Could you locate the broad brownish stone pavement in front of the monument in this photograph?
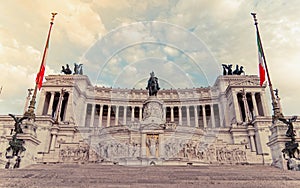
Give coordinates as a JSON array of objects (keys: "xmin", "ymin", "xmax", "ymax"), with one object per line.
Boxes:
[{"xmin": 0, "ymin": 164, "xmax": 300, "ymax": 188}]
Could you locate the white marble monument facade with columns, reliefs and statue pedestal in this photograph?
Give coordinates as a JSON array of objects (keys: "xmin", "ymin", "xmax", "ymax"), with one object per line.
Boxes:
[{"xmin": 0, "ymin": 73, "xmax": 300, "ymax": 167}]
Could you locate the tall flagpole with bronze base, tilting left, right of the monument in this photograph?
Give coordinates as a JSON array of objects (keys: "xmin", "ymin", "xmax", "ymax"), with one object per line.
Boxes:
[{"xmin": 251, "ymin": 13, "xmax": 283, "ymax": 120}]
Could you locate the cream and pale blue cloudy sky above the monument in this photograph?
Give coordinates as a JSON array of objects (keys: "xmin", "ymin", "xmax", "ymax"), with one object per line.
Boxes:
[{"xmin": 0, "ymin": 0, "xmax": 300, "ymax": 115}]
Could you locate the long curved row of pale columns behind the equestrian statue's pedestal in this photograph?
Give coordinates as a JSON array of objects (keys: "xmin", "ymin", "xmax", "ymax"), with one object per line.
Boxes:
[{"xmin": 82, "ymin": 103, "xmax": 223, "ymax": 128}]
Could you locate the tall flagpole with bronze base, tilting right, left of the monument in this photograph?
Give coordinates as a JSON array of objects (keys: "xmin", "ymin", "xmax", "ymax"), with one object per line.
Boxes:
[{"xmin": 24, "ymin": 13, "xmax": 57, "ymax": 120}]
